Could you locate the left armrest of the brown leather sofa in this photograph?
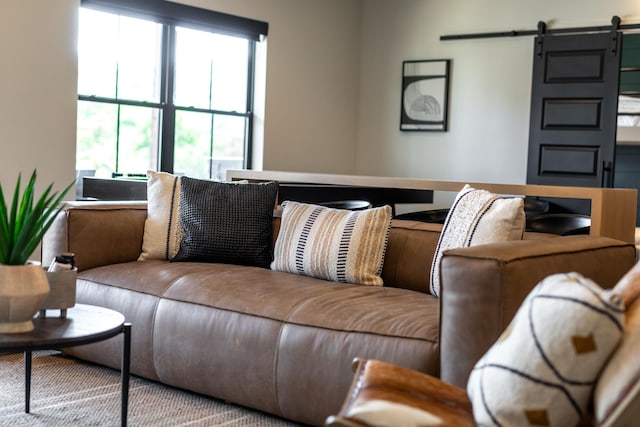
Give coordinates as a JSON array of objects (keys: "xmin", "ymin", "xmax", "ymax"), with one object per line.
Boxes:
[{"xmin": 42, "ymin": 202, "xmax": 147, "ymax": 271}]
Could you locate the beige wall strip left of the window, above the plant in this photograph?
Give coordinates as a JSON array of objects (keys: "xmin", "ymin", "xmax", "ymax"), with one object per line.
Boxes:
[{"xmin": 0, "ymin": 0, "xmax": 79, "ymax": 197}]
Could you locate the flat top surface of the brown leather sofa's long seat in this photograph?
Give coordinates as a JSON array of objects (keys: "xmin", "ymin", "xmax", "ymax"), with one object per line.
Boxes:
[{"xmin": 78, "ymin": 260, "xmax": 439, "ymax": 343}]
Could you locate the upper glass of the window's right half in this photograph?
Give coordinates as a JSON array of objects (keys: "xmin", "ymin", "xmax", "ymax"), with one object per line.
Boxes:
[{"xmin": 174, "ymin": 27, "xmax": 249, "ymax": 112}]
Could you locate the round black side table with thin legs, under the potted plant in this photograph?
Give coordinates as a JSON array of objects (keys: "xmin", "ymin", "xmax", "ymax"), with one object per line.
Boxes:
[{"xmin": 0, "ymin": 304, "xmax": 131, "ymax": 426}]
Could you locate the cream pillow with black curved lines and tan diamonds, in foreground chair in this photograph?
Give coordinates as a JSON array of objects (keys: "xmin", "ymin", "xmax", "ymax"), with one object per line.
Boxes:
[{"xmin": 467, "ymin": 273, "xmax": 624, "ymax": 426}]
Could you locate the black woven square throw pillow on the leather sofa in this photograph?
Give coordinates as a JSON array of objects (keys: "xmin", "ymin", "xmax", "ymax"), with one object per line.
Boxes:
[{"xmin": 171, "ymin": 177, "xmax": 278, "ymax": 268}]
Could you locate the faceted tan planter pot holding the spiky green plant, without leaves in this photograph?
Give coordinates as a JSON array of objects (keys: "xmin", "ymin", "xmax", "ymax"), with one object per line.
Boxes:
[{"xmin": 0, "ymin": 264, "xmax": 49, "ymax": 334}]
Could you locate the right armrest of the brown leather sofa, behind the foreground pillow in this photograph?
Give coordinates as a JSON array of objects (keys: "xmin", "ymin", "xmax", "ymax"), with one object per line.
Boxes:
[{"xmin": 440, "ymin": 236, "xmax": 636, "ymax": 387}]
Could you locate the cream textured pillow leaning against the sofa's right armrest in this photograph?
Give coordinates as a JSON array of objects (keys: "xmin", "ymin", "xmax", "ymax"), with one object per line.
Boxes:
[{"xmin": 430, "ymin": 185, "xmax": 526, "ymax": 296}]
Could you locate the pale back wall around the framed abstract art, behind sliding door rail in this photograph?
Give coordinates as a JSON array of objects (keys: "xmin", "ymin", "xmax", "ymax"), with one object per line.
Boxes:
[{"xmin": 356, "ymin": 0, "xmax": 640, "ymax": 192}]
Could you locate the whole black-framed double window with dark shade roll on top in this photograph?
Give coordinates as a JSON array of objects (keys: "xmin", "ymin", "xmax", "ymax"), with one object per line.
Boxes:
[{"xmin": 76, "ymin": 0, "xmax": 267, "ymax": 179}]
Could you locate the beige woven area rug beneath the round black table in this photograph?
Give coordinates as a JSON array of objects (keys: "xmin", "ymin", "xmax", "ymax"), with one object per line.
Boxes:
[{"xmin": 0, "ymin": 351, "xmax": 299, "ymax": 427}]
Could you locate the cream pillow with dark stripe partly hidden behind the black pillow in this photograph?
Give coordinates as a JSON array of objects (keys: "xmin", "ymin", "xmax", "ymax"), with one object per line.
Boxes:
[{"xmin": 138, "ymin": 171, "xmax": 183, "ymax": 261}]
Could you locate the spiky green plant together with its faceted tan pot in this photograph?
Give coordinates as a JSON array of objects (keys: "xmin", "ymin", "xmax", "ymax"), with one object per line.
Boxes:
[{"xmin": 0, "ymin": 170, "xmax": 75, "ymax": 333}]
